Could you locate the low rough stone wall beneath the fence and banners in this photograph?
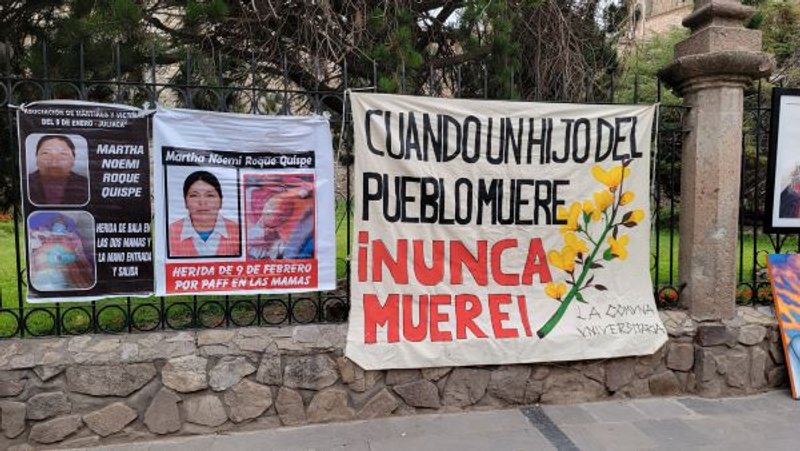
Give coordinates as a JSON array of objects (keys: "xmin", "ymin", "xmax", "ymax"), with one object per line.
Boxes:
[{"xmin": 0, "ymin": 308, "xmax": 786, "ymax": 449}]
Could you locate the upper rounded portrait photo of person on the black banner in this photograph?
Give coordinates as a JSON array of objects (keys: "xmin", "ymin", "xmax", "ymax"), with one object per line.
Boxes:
[{"xmin": 25, "ymin": 133, "xmax": 89, "ymax": 206}]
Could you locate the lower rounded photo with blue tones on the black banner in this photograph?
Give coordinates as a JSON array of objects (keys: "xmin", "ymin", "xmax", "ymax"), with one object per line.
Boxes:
[{"xmin": 27, "ymin": 211, "xmax": 97, "ymax": 291}]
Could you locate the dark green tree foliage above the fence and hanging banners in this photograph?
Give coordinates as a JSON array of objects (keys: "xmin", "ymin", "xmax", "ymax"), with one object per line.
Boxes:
[{"xmin": 0, "ymin": 0, "xmax": 620, "ymax": 210}]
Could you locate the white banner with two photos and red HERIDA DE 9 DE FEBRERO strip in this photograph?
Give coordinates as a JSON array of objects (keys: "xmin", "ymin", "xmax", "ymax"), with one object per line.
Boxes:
[{"xmin": 153, "ymin": 109, "xmax": 336, "ymax": 295}]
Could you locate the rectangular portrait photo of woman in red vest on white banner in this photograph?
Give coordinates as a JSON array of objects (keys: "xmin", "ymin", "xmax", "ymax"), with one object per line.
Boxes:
[{"xmin": 167, "ymin": 166, "xmax": 241, "ymax": 258}]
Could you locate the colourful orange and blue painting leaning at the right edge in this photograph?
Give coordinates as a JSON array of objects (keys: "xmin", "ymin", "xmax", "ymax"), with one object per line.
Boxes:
[{"xmin": 767, "ymin": 254, "xmax": 800, "ymax": 399}]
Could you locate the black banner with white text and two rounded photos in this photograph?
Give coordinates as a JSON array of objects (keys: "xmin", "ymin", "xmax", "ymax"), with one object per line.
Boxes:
[{"xmin": 17, "ymin": 100, "xmax": 153, "ymax": 302}]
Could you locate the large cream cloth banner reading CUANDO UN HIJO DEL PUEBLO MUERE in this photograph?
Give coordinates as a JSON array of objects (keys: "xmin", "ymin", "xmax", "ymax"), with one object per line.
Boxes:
[{"xmin": 346, "ymin": 94, "xmax": 667, "ymax": 369}]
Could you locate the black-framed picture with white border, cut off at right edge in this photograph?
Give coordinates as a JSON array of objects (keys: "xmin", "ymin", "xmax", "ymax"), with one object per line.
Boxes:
[{"xmin": 764, "ymin": 88, "xmax": 800, "ymax": 233}]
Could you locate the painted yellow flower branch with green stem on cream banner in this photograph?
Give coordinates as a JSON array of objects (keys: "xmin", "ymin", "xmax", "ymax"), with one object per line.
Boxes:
[{"xmin": 536, "ymin": 160, "xmax": 645, "ymax": 338}]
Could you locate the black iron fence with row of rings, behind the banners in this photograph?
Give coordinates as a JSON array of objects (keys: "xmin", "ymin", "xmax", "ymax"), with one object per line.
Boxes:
[{"xmin": 0, "ymin": 41, "xmax": 780, "ymax": 338}]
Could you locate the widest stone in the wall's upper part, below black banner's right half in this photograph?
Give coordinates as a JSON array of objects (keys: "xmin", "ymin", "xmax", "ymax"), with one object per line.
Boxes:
[{"xmin": 67, "ymin": 363, "xmax": 156, "ymax": 396}]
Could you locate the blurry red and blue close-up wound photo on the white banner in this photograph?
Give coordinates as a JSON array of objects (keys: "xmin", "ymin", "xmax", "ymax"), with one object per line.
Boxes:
[{"xmin": 243, "ymin": 174, "xmax": 315, "ymax": 260}]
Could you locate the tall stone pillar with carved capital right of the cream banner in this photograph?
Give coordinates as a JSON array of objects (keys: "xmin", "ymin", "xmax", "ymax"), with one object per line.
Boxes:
[{"xmin": 659, "ymin": 0, "xmax": 775, "ymax": 320}]
